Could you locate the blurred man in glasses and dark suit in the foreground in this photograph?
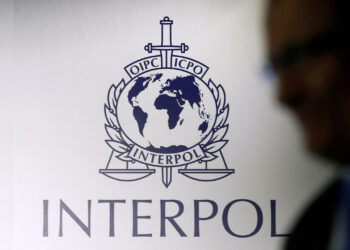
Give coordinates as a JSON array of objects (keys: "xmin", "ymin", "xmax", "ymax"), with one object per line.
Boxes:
[{"xmin": 267, "ymin": 0, "xmax": 350, "ymax": 250}]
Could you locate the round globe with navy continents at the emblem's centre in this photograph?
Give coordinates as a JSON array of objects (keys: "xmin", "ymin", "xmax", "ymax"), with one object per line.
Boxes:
[{"xmin": 117, "ymin": 69, "xmax": 217, "ymax": 153}]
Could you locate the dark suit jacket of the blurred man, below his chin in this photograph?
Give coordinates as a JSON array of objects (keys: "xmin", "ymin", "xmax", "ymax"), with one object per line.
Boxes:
[{"xmin": 285, "ymin": 180, "xmax": 340, "ymax": 250}]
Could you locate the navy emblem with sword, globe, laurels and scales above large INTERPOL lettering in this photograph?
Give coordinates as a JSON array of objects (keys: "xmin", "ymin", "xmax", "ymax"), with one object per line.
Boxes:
[{"xmin": 100, "ymin": 17, "xmax": 234, "ymax": 187}]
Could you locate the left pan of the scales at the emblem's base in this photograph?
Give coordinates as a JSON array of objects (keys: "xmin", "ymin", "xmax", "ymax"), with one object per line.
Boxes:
[{"xmin": 99, "ymin": 169, "xmax": 155, "ymax": 181}]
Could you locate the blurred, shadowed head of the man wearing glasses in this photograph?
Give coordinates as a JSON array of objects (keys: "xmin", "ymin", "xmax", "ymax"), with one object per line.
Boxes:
[{"xmin": 267, "ymin": 0, "xmax": 350, "ymax": 164}]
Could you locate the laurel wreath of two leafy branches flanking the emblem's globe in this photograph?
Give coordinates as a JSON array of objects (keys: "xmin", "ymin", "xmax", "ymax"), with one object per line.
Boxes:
[{"xmin": 104, "ymin": 79, "xmax": 229, "ymax": 162}]
